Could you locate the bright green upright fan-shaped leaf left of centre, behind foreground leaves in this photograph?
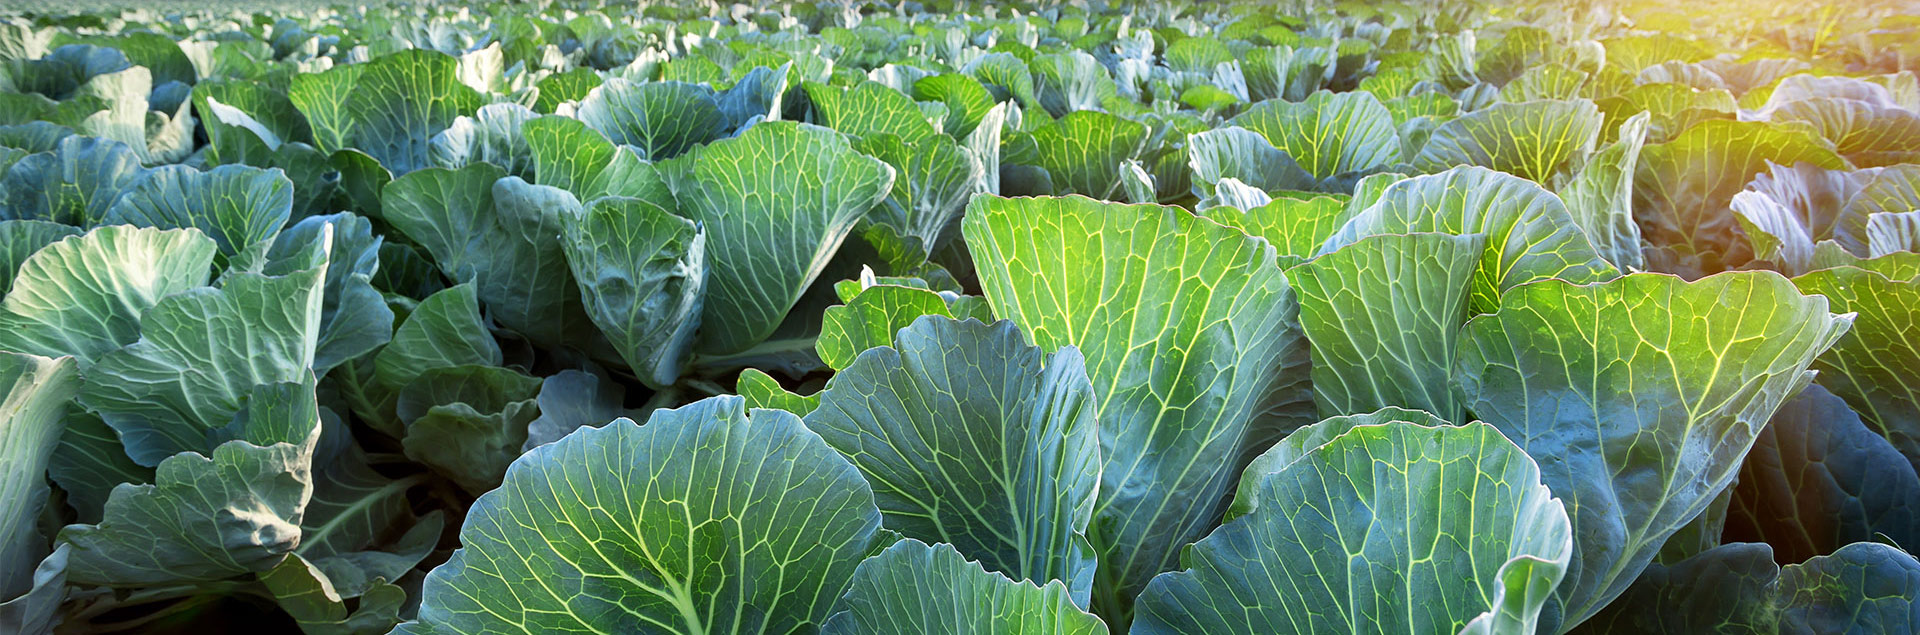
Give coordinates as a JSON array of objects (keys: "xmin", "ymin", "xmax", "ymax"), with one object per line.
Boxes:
[{"xmin": 659, "ymin": 121, "xmax": 895, "ymax": 355}]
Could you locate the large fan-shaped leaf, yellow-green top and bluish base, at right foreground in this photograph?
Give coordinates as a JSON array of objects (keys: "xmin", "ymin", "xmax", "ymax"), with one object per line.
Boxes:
[{"xmin": 1455, "ymin": 272, "xmax": 1853, "ymax": 631}]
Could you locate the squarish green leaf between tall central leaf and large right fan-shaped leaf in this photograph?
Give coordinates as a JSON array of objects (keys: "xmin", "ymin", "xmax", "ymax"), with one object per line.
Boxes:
[{"xmin": 1286, "ymin": 234, "xmax": 1486, "ymax": 420}]
